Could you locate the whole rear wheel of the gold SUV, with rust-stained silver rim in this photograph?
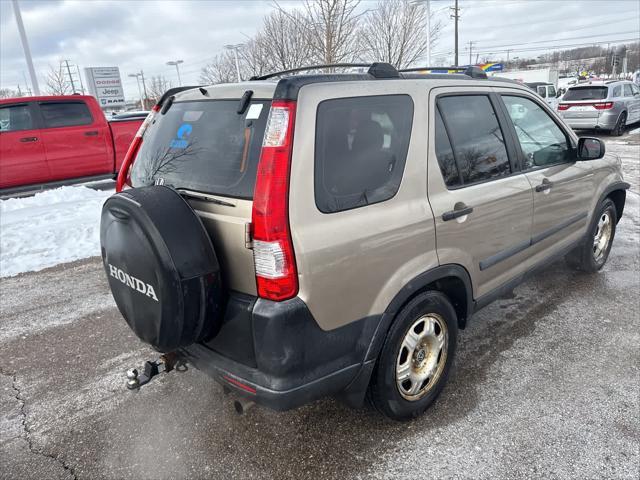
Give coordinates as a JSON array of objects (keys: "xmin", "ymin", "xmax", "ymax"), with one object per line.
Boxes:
[{"xmin": 368, "ymin": 291, "xmax": 458, "ymax": 420}]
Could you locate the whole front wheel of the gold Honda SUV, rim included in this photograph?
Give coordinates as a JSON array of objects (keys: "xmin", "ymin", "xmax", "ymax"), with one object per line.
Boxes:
[{"xmin": 566, "ymin": 198, "xmax": 618, "ymax": 273}]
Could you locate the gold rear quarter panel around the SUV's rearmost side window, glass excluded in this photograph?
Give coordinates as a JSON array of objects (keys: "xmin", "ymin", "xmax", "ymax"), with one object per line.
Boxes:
[{"xmin": 289, "ymin": 80, "xmax": 438, "ymax": 330}]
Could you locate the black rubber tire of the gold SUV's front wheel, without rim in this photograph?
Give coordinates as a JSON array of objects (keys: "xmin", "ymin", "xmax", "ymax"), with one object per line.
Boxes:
[{"xmin": 566, "ymin": 198, "xmax": 618, "ymax": 273}]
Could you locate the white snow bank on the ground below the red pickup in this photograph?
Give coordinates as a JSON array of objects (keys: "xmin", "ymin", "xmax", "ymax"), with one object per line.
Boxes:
[{"xmin": 0, "ymin": 186, "xmax": 113, "ymax": 277}]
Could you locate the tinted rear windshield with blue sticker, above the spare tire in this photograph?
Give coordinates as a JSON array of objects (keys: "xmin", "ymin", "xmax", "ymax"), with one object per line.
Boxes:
[{"xmin": 131, "ymin": 99, "xmax": 271, "ymax": 199}]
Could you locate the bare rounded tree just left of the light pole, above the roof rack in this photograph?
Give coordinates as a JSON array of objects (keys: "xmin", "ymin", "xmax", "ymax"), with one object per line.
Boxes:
[{"xmin": 360, "ymin": 0, "xmax": 442, "ymax": 68}]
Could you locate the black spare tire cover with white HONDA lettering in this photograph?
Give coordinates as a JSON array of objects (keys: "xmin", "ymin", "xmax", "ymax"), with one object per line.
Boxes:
[{"xmin": 100, "ymin": 185, "xmax": 221, "ymax": 352}]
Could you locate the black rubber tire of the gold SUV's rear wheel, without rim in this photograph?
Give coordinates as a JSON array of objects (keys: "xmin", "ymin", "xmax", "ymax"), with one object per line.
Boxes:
[{"xmin": 368, "ymin": 291, "xmax": 458, "ymax": 420}]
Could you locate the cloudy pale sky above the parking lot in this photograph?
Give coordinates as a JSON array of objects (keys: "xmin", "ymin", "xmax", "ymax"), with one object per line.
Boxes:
[{"xmin": 0, "ymin": 0, "xmax": 640, "ymax": 99}]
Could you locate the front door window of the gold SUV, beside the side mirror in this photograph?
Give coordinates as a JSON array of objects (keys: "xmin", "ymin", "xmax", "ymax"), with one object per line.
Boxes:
[{"xmin": 502, "ymin": 95, "xmax": 573, "ymax": 169}]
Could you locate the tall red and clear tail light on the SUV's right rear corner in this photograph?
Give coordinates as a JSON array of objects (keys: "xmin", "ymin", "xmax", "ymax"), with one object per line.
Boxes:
[{"xmin": 251, "ymin": 101, "xmax": 298, "ymax": 301}]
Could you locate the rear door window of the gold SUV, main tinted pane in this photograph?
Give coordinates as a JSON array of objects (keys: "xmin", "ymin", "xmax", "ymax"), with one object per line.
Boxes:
[{"xmin": 438, "ymin": 95, "xmax": 511, "ymax": 185}]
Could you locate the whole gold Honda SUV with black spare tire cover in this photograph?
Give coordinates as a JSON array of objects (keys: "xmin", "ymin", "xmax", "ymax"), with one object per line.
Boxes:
[{"xmin": 101, "ymin": 63, "xmax": 629, "ymax": 419}]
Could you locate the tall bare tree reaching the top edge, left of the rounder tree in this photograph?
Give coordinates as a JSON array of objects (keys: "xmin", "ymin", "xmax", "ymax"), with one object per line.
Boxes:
[{"xmin": 302, "ymin": 0, "xmax": 362, "ymax": 64}]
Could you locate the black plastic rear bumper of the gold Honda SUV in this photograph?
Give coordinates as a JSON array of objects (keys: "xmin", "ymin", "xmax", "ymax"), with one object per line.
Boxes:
[{"xmin": 181, "ymin": 294, "xmax": 380, "ymax": 410}]
